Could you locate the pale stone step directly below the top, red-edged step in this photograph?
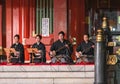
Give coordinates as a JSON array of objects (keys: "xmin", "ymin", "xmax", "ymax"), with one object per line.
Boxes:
[{"xmin": 0, "ymin": 71, "xmax": 94, "ymax": 79}]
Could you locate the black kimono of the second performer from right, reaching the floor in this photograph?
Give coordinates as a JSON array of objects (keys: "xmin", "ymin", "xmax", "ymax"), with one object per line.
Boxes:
[{"xmin": 50, "ymin": 40, "xmax": 73, "ymax": 63}]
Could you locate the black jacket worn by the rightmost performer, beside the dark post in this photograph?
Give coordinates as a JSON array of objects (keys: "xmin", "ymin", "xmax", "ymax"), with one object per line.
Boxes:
[{"xmin": 76, "ymin": 41, "xmax": 94, "ymax": 55}]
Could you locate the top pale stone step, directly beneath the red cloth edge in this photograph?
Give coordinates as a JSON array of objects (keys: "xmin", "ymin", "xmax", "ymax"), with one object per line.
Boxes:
[{"xmin": 0, "ymin": 65, "xmax": 94, "ymax": 72}]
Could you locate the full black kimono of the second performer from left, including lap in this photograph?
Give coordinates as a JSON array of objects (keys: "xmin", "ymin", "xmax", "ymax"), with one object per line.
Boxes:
[{"xmin": 32, "ymin": 42, "xmax": 46, "ymax": 63}]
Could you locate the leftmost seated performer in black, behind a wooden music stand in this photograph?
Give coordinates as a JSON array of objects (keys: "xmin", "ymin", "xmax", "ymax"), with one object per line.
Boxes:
[{"xmin": 10, "ymin": 34, "xmax": 24, "ymax": 63}]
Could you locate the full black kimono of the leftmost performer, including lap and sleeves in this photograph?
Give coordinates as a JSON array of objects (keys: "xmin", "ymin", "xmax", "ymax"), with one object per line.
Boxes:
[{"xmin": 10, "ymin": 43, "xmax": 25, "ymax": 63}]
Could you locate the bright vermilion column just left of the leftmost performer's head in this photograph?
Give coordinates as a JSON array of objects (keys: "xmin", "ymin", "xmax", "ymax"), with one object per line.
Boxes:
[{"xmin": 6, "ymin": 0, "xmax": 13, "ymax": 47}]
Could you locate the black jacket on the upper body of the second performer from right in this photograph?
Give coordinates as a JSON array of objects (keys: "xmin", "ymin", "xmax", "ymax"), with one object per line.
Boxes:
[{"xmin": 50, "ymin": 40, "xmax": 73, "ymax": 57}]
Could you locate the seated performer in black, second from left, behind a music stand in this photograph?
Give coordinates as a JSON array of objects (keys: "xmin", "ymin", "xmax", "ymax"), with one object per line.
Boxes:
[{"xmin": 30, "ymin": 35, "xmax": 46, "ymax": 63}]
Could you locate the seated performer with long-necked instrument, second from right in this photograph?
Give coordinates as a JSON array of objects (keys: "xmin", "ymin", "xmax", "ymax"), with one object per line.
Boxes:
[{"xmin": 50, "ymin": 31, "xmax": 73, "ymax": 63}]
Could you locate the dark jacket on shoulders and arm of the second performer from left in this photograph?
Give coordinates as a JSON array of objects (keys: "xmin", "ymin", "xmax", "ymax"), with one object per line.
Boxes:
[{"xmin": 32, "ymin": 42, "xmax": 46, "ymax": 63}]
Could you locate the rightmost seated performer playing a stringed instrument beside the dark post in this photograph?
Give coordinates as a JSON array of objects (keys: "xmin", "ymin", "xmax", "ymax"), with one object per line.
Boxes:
[{"xmin": 76, "ymin": 34, "xmax": 94, "ymax": 63}]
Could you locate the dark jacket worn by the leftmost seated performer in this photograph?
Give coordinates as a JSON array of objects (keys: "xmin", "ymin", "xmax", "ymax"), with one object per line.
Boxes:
[{"xmin": 11, "ymin": 43, "xmax": 25, "ymax": 63}]
